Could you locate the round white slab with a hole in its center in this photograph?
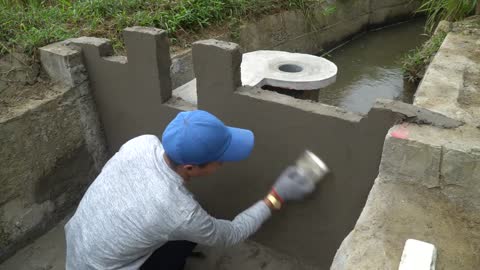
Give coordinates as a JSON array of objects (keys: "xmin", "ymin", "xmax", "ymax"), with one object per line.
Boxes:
[{"xmin": 241, "ymin": 51, "xmax": 337, "ymax": 90}]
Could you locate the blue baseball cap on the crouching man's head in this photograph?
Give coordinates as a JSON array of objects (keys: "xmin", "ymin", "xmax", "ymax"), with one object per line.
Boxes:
[{"xmin": 162, "ymin": 110, "xmax": 254, "ymax": 165}]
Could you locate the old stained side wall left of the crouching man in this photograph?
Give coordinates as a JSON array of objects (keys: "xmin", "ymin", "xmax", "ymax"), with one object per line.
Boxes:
[{"xmin": 0, "ymin": 44, "xmax": 107, "ymax": 261}]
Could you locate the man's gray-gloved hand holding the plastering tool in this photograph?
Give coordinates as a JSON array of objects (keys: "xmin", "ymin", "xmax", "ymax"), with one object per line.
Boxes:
[{"xmin": 273, "ymin": 166, "xmax": 315, "ymax": 201}]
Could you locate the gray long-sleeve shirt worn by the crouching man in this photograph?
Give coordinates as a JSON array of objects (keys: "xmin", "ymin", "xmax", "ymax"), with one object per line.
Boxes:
[{"xmin": 65, "ymin": 135, "xmax": 271, "ymax": 270}]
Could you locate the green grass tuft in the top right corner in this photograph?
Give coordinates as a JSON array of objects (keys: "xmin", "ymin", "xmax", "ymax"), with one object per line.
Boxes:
[{"xmin": 417, "ymin": 0, "xmax": 477, "ymax": 33}]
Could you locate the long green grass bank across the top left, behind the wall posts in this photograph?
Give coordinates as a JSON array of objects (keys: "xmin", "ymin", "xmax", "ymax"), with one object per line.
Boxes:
[{"xmin": 0, "ymin": 0, "xmax": 334, "ymax": 55}]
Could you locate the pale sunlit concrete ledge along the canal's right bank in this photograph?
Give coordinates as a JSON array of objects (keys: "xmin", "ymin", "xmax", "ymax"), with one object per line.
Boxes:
[{"xmin": 414, "ymin": 16, "xmax": 480, "ymax": 126}]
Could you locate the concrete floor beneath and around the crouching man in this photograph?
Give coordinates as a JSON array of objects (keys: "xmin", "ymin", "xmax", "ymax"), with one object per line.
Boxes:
[{"xmin": 0, "ymin": 219, "xmax": 316, "ymax": 270}]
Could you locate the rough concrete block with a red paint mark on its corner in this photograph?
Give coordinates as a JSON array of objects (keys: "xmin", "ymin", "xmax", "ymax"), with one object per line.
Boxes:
[{"xmin": 380, "ymin": 129, "xmax": 442, "ymax": 188}]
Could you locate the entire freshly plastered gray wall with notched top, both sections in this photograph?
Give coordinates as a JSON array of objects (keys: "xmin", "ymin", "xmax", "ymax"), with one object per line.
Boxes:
[{"xmin": 39, "ymin": 27, "xmax": 456, "ymax": 268}]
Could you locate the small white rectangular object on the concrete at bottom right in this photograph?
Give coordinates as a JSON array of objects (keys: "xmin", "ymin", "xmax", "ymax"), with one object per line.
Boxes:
[{"xmin": 398, "ymin": 239, "xmax": 437, "ymax": 270}]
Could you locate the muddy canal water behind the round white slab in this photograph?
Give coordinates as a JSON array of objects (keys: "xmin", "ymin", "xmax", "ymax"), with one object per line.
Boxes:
[{"xmin": 319, "ymin": 19, "xmax": 427, "ymax": 113}]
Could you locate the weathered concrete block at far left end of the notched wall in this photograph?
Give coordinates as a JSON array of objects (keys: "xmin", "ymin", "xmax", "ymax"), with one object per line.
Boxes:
[{"xmin": 40, "ymin": 42, "xmax": 87, "ymax": 87}]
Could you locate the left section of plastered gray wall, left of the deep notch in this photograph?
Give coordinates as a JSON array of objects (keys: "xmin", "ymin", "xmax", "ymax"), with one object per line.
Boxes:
[{"xmin": 66, "ymin": 27, "xmax": 184, "ymax": 153}]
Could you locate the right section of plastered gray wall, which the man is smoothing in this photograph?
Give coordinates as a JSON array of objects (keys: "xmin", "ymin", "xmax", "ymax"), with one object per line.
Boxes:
[{"xmin": 188, "ymin": 40, "xmax": 460, "ymax": 269}]
